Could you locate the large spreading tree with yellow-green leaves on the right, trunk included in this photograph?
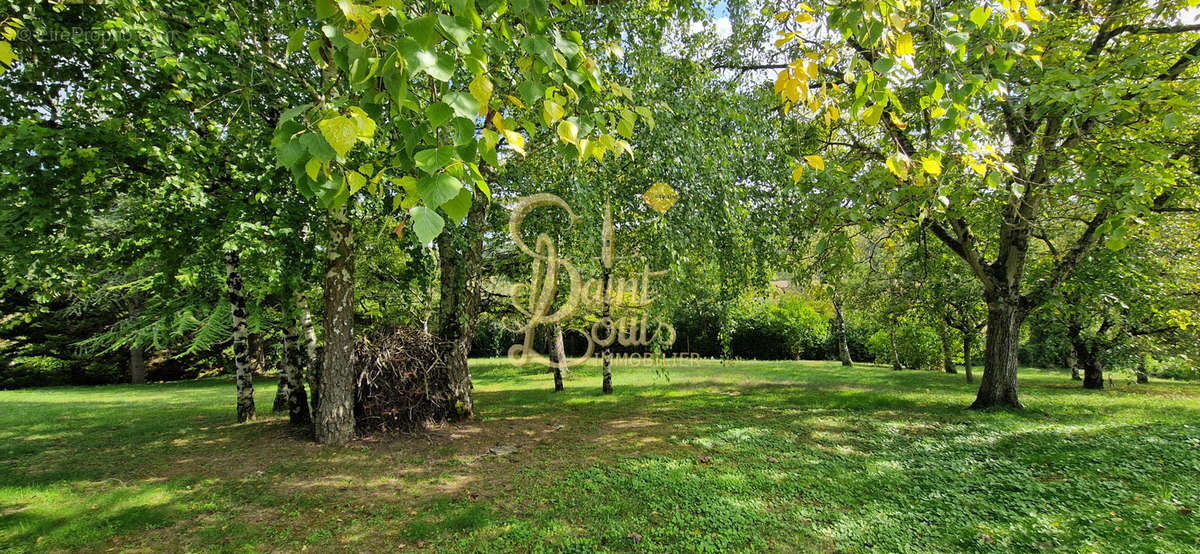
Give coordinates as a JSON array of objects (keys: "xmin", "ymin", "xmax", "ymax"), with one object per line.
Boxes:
[{"xmin": 775, "ymin": 0, "xmax": 1200, "ymax": 409}]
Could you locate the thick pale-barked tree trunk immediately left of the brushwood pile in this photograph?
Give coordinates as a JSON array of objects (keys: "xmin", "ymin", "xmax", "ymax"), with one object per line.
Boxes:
[{"xmin": 316, "ymin": 206, "xmax": 356, "ymax": 445}]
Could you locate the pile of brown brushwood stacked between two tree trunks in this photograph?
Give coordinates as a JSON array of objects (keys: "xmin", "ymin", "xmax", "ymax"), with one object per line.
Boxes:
[{"xmin": 354, "ymin": 327, "xmax": 455, "ymax": 434}]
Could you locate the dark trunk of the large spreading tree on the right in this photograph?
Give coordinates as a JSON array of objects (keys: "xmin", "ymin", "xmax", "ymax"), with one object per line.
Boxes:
[{"xmin": 971, "ymin": 300, "xmax": 1025, "ymax": 410}]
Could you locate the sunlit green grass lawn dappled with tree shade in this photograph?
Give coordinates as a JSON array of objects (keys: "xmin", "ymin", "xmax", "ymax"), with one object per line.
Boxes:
[{"xmin": 0, "ymin": 360, "xmax": 1200, "ymax": 553}]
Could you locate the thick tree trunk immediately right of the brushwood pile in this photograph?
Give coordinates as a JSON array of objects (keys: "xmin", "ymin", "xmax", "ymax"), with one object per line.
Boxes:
[{"xmin": 438, "ymin": 198, "xmax": 487, "ymax": 420}]
